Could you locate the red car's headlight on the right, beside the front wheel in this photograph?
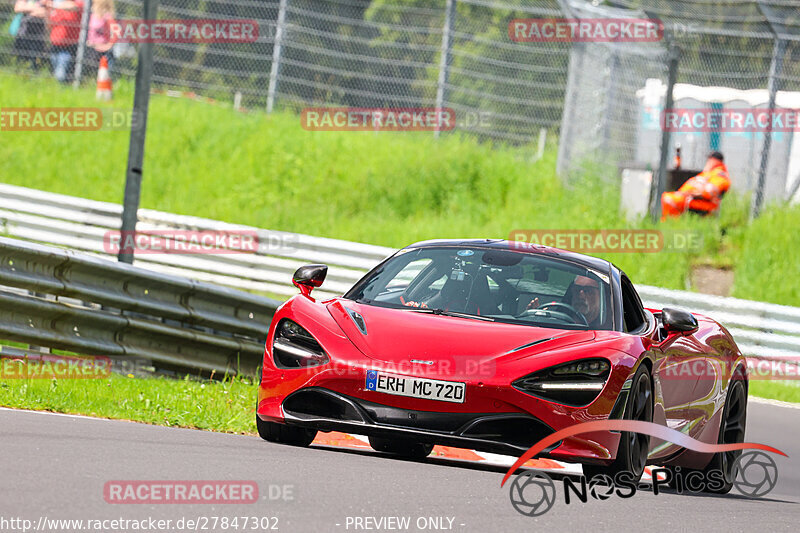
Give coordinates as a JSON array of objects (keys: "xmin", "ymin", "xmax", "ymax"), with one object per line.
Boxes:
[{"xmin": 511, "ymin": 359, "xmax": 611, "ymax": 407}]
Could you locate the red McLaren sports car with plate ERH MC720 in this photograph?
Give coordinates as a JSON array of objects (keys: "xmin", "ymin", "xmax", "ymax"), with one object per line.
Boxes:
[{"xmin": 256, "ymin": 240, "xmax": 748, "ymax": 492}]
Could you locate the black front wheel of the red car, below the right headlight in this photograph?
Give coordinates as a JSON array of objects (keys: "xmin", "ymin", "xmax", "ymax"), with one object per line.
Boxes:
[{"xmin": 583, "ymin": 365, "xmax": 653, "ymax": 483}]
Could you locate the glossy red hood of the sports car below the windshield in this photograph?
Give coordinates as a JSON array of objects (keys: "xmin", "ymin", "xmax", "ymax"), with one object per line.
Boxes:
[{"xmin": 328, "ymin": 298, "xmax": 595, "ymax": 364}]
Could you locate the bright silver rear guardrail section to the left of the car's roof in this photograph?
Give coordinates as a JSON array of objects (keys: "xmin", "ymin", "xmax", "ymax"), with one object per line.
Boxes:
[{"xmin": 0, "ymin": 184, "xmax": 394, "ymax": 296}]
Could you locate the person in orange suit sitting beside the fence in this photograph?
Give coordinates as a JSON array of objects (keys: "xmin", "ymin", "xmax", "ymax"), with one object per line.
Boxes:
[{"xmin": 661, "ymin": 152, "xmax": 731, "ymax": 220}]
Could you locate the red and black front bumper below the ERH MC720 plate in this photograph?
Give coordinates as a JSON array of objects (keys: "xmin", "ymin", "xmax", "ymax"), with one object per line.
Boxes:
[{"xmin": 257, "ymin": 358, "xmax": 627, "ymax": 464}]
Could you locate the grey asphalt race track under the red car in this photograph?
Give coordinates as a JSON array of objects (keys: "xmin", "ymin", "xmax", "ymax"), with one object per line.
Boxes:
[{"xmin": 0, "ymin": 401, "xmax": 800, "ymax": 533}]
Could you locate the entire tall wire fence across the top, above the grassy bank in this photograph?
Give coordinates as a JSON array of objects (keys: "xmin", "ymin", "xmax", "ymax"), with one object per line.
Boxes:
[{"xmin": 0, "ymin": 0, "xmax": 800, "ymax": 214}]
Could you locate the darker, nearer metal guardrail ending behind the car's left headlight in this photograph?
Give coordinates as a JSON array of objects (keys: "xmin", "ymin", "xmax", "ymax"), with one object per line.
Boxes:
[{"xmin": 0, "ymin": 237, "xmax": 280, "ymax": 374}]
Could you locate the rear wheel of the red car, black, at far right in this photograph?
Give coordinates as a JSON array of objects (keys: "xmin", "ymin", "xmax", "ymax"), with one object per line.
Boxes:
[{"xmin": 703, "ymin": 376, "xmax": 747, "ymax": 494}]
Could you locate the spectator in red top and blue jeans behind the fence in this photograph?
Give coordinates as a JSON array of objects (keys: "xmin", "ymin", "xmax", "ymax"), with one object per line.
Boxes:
[{"xmin": 45, "ymin": 0, "xmax": 83, "ymax": 83}]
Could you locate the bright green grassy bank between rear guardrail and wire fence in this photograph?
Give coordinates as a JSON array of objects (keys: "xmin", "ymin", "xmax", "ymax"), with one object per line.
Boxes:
[{"xmin": 0, "ymin": 73, "xmax": 800, "ymax": 305}]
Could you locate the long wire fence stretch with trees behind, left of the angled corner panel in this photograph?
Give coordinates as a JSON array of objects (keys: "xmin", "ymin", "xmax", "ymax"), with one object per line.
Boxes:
[{"xmin": 0, "ymin": 0, "xmax": 570, "ymax": 144}]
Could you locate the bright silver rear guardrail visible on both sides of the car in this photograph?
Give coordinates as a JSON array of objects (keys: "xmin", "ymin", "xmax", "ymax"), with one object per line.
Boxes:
[{"xmin": 0, "ymin": 184, "xmax": 800, "ymax": 361}]
